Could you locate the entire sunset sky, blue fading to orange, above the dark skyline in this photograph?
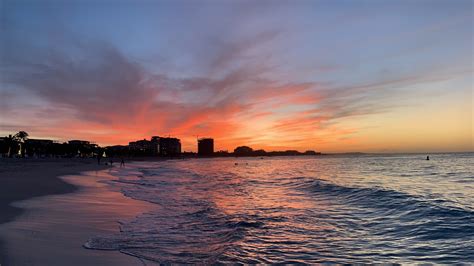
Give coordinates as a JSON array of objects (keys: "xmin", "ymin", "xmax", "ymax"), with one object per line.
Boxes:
[{"xmin": 0, "ymin": 0, "xmax": 474, "ymax": 152}]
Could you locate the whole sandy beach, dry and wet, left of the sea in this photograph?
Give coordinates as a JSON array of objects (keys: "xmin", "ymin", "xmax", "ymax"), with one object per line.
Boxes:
[{"xmin": 0, "ymin": 159, "xmax": 154, "ymax": 265}]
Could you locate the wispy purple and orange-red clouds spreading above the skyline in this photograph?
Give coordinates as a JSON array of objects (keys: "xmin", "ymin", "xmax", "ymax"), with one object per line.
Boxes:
[{"xmin": 2, "ymin": 31, "xmax": 466, "ymax": 152}]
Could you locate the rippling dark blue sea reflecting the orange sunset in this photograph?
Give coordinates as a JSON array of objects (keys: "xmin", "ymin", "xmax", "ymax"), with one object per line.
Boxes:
[{"xmin": 85, "ymin": 153, "xmax": 474, "ymax": 263}]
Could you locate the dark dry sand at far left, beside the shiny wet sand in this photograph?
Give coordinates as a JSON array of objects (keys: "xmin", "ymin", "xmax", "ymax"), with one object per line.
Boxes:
[{"xmin": 0, "ymin": 158, "xmax": 112, "ymax": 265}]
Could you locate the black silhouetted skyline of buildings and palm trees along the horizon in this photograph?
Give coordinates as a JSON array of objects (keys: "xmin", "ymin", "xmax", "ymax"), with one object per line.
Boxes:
[{"xmin": 0, "ymin": 131, "xmax": 322, "ymax": 158}]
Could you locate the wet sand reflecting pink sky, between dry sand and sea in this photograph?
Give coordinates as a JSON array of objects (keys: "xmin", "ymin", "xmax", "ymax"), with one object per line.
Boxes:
[{"xmin": 0, "ymin": 162, "xmax": 154, "ymax": 265}]
